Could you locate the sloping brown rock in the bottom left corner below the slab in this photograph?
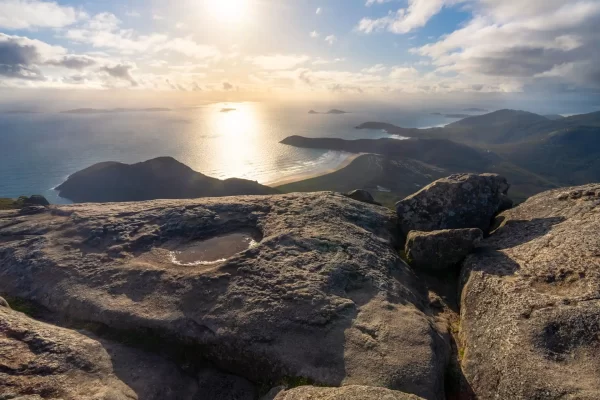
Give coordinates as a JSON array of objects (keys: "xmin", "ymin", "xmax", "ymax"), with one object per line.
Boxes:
[{"xmin": 0, "ymin": 307, "xmax": 137, "ymax": 400}]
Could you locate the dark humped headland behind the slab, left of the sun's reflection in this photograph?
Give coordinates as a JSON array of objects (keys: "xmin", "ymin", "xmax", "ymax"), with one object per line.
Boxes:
[{"xmin": 55, "ymin": 157, "xmax": 278, "ymax": 203}]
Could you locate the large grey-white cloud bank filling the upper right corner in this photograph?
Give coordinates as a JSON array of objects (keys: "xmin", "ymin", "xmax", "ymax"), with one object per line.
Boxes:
[{"xmin": 412, "ymin": 0, "xmax": 600, "ymax": 90}]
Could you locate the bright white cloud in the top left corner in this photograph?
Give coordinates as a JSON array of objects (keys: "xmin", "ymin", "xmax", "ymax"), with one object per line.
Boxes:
[{"xmin": 0, "ymin": 0, "xmax": 87, "ymax": 30}]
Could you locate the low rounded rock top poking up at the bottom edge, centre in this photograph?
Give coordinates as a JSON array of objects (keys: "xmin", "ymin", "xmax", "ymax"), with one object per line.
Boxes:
[{"xmin": 275, "ymin": 386, "xmax": 421, "ymax": 400}]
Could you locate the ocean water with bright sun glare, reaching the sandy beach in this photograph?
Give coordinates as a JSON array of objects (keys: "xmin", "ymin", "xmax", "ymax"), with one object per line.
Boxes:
[{"xmin": 0, "ymin": 103, "xmax": 455, "ymax": 203}]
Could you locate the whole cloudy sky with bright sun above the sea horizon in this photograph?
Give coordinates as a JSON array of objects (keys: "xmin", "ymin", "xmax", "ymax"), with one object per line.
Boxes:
[{"xmin": 0, "ymin": 0, "xmax": 600, "ymax": 107}]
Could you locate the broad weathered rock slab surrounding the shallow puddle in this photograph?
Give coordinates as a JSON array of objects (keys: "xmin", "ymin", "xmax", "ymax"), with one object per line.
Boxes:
[{"xmin": 0, "ymin": 193, "xmax": 449, "ymax": 399}]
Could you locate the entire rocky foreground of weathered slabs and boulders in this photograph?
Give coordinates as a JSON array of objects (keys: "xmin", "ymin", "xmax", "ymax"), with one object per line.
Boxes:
[{"xmin": 0, "ymin": 175, "xmax": 600, "ymax": 400}]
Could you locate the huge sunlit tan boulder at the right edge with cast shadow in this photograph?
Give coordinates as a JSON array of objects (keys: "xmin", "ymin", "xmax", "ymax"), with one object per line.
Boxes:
[{"xmin": 460, "ymin": 184, "xmax": 600, "ymax": 400}]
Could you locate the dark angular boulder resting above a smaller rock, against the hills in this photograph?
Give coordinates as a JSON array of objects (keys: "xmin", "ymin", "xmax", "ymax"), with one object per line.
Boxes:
[{"xmin": 396, "ymin": 174, "xmax": 510, "ymax": 235}]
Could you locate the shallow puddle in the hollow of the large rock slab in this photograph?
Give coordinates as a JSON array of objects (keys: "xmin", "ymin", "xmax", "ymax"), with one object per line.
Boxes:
[{"xmin": 163, "ymin": 231, "xmax": 260, "ymax": 266}]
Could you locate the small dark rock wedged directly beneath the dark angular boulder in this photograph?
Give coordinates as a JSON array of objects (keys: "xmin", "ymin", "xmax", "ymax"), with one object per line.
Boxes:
[{"xmin": 404, "ymin": 228, "xmax": 483, "ymax": 270}]
